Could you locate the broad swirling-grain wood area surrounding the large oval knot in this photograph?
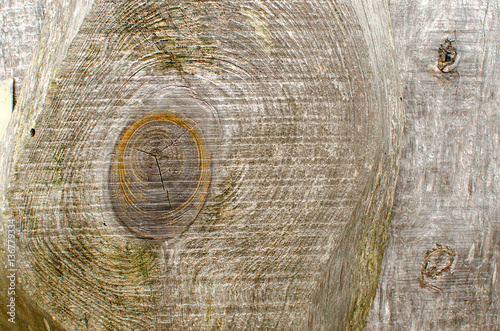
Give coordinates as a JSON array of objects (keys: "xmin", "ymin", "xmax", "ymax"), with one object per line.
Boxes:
[{"xmin": 2, "ymin": 1, "xmax": 402, "ymax": 330}]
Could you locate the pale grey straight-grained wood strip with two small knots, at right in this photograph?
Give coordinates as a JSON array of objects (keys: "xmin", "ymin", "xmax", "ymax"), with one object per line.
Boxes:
[{"xmin": 365, "ymin": 0, "xmax": 500, "ymax": 330}]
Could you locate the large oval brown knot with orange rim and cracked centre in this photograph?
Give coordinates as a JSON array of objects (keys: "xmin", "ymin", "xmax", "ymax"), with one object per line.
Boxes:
[{"xmin": 109, "ymin": 113, "xmax": 210, "ymax": 239}]
